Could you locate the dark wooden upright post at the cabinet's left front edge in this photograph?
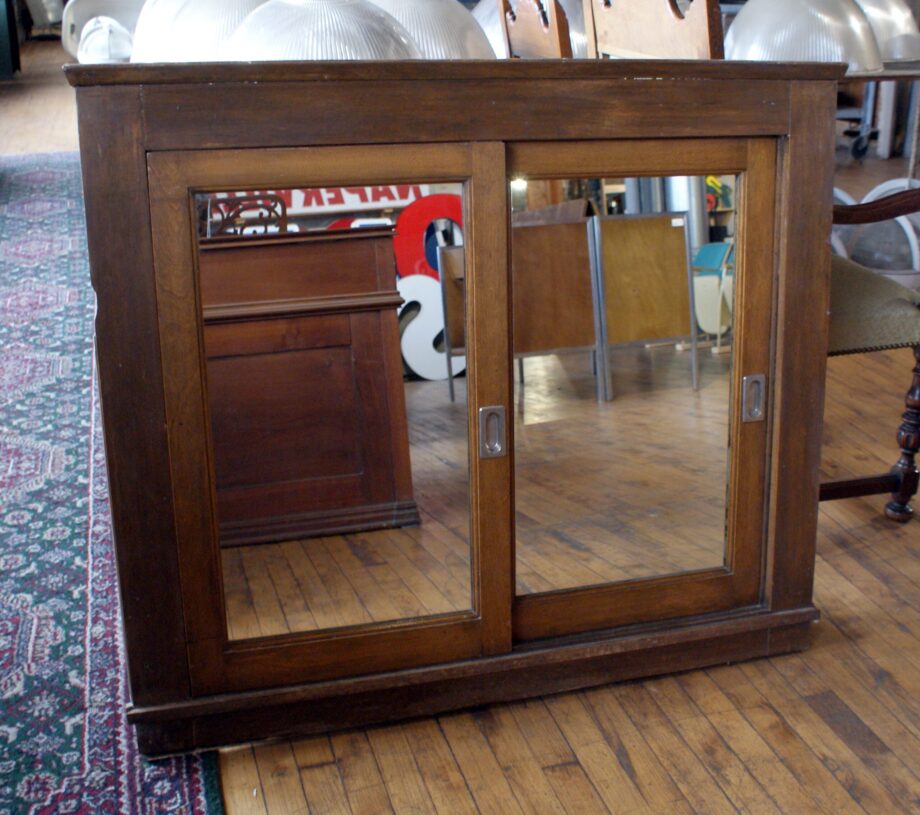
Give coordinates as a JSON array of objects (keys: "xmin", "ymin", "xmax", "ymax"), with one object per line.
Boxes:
[{"xmin": 77, "ymin": 87, "xmax": 189, "ymax": 705}]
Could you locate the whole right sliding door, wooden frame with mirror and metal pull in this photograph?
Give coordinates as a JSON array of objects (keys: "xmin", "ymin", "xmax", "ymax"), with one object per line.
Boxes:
[{"xmin": 508, "ymin": 140, "xmax": 776, "ymax": 640}]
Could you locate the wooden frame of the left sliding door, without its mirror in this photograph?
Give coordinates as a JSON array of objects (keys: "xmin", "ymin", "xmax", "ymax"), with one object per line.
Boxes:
[{"xmin": 147, "ymin": 142, "xmax": 511, "ymax": 694}]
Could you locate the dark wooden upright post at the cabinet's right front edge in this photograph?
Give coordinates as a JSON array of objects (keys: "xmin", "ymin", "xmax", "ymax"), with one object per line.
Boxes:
[{"xmin": 767, "ymin": 82, "xmax": 836, "ymax": 610}]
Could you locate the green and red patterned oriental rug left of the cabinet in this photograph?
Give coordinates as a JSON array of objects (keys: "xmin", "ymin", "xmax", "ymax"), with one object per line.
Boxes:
[{"xmin": 0, "ymin": 154, "xmax": 221, "ymax": 815}]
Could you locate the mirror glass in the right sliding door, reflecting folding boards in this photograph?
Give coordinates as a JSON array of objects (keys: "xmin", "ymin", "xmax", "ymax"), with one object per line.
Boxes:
[{"xmin": 509, "ymin": 176, "xmax": 738, "ymax": 594}]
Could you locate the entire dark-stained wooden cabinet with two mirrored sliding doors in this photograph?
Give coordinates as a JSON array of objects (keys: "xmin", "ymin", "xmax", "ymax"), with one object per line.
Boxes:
[{"xmin": 67, "ymin": 61, "xmax": 841, "ymax": 754}]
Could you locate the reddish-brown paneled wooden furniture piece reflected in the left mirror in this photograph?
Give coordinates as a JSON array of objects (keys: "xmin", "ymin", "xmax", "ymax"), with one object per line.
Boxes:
[{"xmin": 199, "ymin": 230, "xmax": 418, "ymax": 546}]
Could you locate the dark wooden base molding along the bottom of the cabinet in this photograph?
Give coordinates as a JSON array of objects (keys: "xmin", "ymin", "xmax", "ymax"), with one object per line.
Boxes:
[{"xmin": 128, "ymin": 606, "xmax": 819, "ymax": 756}]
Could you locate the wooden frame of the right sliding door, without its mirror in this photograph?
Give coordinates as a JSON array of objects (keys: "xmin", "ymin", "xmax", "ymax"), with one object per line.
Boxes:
[{"xmin": 507, "ymin": 138, "xmax": 779, "ymax": 642}]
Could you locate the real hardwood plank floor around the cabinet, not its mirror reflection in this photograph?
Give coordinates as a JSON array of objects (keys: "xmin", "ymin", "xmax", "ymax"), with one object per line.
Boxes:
[{"xmin": 0, "ymin": 43, "xmax": 920, "ymax": 815}]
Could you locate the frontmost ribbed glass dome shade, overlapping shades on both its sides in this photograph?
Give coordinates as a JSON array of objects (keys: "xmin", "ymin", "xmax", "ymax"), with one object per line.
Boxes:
[{"xmin": 221, "ymin": 0, "xmax": 421, "ymax": 61}]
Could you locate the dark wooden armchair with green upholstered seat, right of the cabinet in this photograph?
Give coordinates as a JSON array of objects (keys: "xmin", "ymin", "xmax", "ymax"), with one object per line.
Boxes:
[{"xmin": 820, "ymin": 190, "xmax": 920, "ymax": 522}]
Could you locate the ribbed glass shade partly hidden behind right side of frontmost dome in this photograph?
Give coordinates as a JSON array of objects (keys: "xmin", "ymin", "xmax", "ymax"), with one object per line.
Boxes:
[{"xmin": 371, "ymin": 0, "xmax": 495, "ymax": 59}]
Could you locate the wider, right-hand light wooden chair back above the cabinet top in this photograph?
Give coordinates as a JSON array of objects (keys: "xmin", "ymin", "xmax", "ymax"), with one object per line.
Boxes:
[{"xmin": 584, "ymin": 0, "xmax": 725, "ymax": 59}]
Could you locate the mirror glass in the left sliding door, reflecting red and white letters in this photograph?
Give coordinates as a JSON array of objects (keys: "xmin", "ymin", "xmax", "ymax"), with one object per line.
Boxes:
[{"xmin": 195, "ymin": 183, "xmax": 473, "ymax": 640}]
